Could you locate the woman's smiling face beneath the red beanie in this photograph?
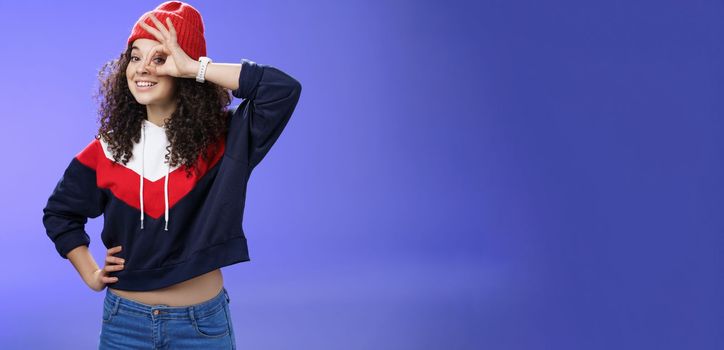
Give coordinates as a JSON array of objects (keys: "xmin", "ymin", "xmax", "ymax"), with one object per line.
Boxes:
[{"xmin": 126, "ymin": 39, "xmax": 175, "ymax": 105}]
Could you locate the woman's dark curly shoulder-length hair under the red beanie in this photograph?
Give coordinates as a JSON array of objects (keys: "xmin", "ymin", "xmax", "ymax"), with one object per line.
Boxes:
[{"xmin": 94, "ymin": 45, "xmax": 231, "ymax": 177}]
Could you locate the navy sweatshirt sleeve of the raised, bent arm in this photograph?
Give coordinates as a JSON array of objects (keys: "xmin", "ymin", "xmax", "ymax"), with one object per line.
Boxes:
[{"xmin": 230, "ymin": 58, "xmax": 302, "ymax": 169}]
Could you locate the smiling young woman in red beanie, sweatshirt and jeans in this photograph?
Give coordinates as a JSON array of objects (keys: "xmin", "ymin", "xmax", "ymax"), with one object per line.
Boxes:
[{"xmin": 43, "ymin": 1, "xmax": 301, "ymax": 349}]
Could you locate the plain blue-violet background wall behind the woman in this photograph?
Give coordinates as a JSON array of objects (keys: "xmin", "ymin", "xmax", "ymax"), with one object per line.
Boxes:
[{"xmin": 0, "ymin": 0, "xmax": 724, "ymax": 349}]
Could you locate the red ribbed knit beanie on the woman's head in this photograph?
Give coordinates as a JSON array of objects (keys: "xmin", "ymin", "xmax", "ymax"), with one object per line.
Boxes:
[{"xmin": 128, "ymin": 1, "xmax": 206, "ymax": 60}]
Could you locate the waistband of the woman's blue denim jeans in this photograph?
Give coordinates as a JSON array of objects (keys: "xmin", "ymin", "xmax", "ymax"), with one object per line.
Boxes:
[{"xmin": 104, "ymin": 287, "xmax": 229, "ymax": 319}]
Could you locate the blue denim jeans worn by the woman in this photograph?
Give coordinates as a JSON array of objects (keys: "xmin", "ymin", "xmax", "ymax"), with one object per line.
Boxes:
[{"xmin": 98, "ymin": 287, "xmax": 236, "ymax": 350}]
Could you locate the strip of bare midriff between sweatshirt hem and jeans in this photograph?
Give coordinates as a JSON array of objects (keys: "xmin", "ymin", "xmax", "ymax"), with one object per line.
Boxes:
[{"xmin": 108, "ymin": 269, "xmax": 224, "ymax": 306}]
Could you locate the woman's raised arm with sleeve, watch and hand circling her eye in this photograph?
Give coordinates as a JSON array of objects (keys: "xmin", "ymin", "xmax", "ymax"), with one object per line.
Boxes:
[{"xmin": 138, "ymin": 13, "xmax": 302, "ymax": 171}]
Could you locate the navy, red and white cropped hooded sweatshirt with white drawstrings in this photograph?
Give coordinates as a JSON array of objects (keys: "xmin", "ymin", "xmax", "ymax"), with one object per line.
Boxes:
[{"xmin": 43, "ymin": 59, "xmax": 302, "ymax": 291}]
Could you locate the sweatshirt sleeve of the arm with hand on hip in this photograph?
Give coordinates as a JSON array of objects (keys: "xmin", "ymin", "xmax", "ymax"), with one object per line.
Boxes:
[{"xmin": 43, "ymin": 139, "xmax": 107, "ymax": 259}]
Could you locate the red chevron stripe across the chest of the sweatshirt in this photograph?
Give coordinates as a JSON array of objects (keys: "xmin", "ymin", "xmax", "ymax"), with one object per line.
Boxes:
[{"xmin": 76, "ymin": 138, "xmax": 226, "ymax": 219}]
